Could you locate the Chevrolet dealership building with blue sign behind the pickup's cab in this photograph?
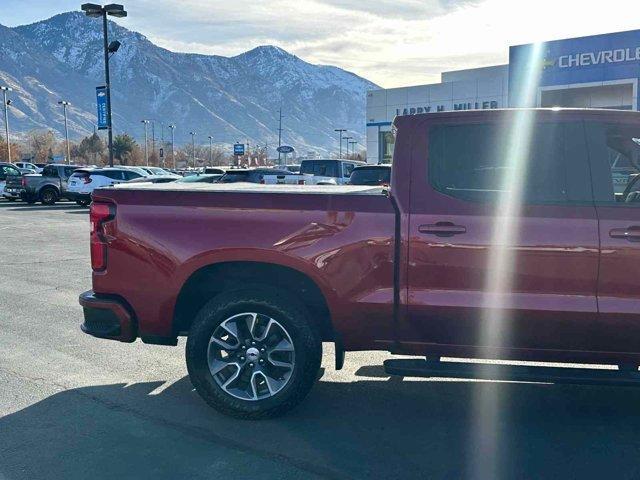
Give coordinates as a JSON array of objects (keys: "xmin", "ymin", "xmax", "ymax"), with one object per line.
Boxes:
[{"xmin": 367, "ymin": 30, "xmax": 640, "ymax": 164}]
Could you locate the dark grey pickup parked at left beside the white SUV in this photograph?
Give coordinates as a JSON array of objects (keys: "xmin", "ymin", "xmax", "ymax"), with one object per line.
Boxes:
[{"xmin": 22, "ymin": 163, "xmax": 79, "ymax": 205}]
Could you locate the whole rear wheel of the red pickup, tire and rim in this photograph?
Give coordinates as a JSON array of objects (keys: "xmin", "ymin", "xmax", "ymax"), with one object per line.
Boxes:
[{"xmin": 186, "ymin": 287, "xmax": 322, "ymax": 419}]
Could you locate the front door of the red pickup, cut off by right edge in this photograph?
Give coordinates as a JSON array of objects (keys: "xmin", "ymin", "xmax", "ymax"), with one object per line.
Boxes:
[{"xmin": 586, "ymin": 120, "xmax": 640, "ymax": 352}]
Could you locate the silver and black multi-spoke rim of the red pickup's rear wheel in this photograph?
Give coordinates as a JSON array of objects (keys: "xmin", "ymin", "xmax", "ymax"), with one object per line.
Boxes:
[{"xmin": 207, "ymin": 312, "xmax": 295, "ymax": 401}]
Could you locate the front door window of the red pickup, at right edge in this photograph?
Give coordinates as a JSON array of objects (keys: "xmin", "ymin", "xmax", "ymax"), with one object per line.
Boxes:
[{"xmin": 586, "ymin": 123, "xmax": 640, "ymax": 204}]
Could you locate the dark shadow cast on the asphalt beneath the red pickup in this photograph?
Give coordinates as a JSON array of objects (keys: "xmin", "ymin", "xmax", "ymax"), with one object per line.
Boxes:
[{"xmin": 0, "ymin": 376, "xmax": 640, "ymax": 479}]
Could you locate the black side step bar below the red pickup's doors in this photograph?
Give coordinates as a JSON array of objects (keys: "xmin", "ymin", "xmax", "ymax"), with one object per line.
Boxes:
[{"xmin": 384, "ymin": 359, "xmax": 640, "ymax": 387}]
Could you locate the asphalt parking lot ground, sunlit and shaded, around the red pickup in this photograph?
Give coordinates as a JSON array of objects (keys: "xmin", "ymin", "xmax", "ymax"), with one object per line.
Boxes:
[{"xmin": 0, "ymin": 201, "xmax": 640, "ymax": 479}]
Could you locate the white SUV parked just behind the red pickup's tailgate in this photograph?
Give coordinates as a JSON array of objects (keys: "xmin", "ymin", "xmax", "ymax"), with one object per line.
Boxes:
[{"xmin": 67, "ymin": 166, "xmax": 148, "ymax": 206}]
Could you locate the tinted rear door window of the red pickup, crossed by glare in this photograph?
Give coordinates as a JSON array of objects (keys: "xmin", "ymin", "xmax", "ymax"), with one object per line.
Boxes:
[{"xmin": 429, "ymin": 123, "xmax": 591, "ymax": 203}]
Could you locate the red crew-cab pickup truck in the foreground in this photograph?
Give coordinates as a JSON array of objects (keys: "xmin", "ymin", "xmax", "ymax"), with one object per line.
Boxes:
[{"xmin": 80, "ymin": 109, "xmax": 640, "ymax": 418}]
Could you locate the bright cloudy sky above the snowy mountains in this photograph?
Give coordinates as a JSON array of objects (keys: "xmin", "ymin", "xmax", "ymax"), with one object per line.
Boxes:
[{"xmin": 0, "ymin": 0, "xmax": 640, "ymax": 88}]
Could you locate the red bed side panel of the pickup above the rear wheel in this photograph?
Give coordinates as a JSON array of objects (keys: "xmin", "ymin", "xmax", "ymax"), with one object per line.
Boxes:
[{"xmin": 93, "ymin": 189, "xmax": 395, "ymax": 349}]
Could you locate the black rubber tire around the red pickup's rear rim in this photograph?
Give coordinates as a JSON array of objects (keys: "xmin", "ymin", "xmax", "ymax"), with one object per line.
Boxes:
[{"xmin": 186, "ymin": 286, "xmax": 322, "ymax": 420}]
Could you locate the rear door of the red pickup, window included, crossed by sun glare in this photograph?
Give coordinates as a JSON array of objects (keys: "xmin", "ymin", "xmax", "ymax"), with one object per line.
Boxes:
[{"xmin": 401, "ymin": 113, "xmax": 598, "ymax": 358}]
